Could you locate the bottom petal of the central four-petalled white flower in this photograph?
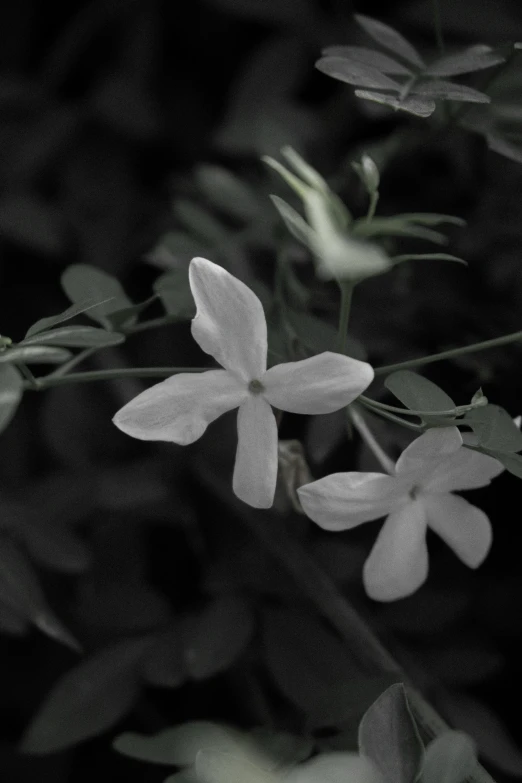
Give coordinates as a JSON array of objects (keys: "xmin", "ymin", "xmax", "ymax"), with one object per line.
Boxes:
[{"xmin": 232, "ymin": 396, "xmax": 278, "ymax": 508}]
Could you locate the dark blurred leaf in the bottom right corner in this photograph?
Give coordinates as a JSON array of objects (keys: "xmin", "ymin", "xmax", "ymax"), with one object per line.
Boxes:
[{"xmin": 440, "ymin": 692, "xmax": 522, "ymax": 778}]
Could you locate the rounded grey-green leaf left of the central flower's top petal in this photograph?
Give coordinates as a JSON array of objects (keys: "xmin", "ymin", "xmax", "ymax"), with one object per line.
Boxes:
[{"xmin": 61, "ymin": 264, "xmax": 136, "ymax": 329}]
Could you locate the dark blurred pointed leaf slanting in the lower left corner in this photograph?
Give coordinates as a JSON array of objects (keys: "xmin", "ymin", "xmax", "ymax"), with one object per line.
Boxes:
[{"xmin": 22, "ymin": 639, "xmax": 150, "ymax": 754}]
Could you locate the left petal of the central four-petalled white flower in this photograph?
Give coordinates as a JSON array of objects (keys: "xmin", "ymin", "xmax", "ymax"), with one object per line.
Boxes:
[{"xmin": 113, "ymin": 370, "xmax": 248, "ymax": 446}]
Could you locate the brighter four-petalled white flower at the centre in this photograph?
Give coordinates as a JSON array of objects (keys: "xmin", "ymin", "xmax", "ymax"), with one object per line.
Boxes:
[{"xmin": 113, "ymin": 258, "xmax": 373, "ymax": 508}]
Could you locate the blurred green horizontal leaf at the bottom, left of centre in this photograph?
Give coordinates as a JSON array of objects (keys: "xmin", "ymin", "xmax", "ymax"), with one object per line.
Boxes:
[{"xmin": 113, "ymin": 721, "xmax": 242, "ymax": 767}]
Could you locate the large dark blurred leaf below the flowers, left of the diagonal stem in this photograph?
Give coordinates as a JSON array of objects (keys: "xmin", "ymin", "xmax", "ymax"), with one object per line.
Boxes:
[{"xmin": 263, "ymin": 609, "xmax": 395, "ymax": 727}]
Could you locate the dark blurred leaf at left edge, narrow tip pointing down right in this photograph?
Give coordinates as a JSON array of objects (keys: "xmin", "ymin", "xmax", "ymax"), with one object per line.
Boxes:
[{"xmin": 0, "ymin": 537, "xmax": 78, "ymax": 649}]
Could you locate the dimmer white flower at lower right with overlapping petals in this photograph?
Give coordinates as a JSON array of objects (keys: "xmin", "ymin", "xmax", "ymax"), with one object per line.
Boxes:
[{"xmin": 297, "ymin": 427, "xmax": 504, "ymax": 601}]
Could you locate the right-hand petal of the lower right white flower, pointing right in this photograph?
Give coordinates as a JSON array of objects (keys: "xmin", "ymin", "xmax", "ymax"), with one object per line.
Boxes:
[{"xmin": 422, "ymin": 446, "xmax": 504, "ymax": 492}]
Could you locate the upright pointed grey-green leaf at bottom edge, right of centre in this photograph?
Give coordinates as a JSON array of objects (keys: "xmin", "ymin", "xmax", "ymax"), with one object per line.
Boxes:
[{"xmin": 359, "ymin": 683, "xmax": 424, "ymax": 783}]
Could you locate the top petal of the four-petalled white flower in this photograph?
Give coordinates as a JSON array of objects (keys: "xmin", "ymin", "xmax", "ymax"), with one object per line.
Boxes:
[{"xmin": 189, "ymin": 258, "xmax": 267, "ymax": 381}]
